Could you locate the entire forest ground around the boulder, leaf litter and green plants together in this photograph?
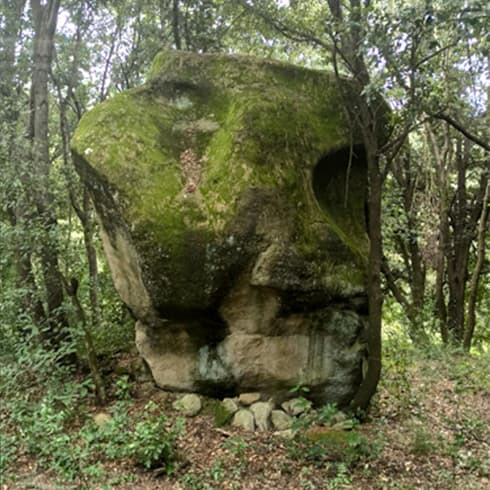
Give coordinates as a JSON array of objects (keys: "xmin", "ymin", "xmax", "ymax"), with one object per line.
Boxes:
[{"xmin": 0, "ymin": 322, "xmax": 490, "ymax": 490}]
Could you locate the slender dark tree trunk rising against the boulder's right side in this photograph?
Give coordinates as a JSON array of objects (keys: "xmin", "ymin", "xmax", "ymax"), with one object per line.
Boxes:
[{"xmin": 232, "ymin": 0, "xmax": 408, "ymax": 409}]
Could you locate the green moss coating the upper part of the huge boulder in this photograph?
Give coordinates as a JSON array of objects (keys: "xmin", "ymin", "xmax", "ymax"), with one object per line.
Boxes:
[{"xmin": 72, "ymin": 52, "xmax": 366, "ymax": 314}]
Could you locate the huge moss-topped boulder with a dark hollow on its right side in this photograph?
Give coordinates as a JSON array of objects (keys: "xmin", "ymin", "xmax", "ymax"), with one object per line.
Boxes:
[{"xmin": 72, "ymin": 52, "xmax": 368, "ymax": 405}]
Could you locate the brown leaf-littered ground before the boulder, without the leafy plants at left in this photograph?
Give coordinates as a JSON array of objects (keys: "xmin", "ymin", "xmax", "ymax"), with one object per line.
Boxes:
[{"xmin": 0, "ymin": 344, "xmax": 490, "ymax": 490}]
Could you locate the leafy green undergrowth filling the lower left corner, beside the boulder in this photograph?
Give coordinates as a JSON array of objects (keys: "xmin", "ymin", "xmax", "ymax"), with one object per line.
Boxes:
[{"xmin": 0, "ymin": 318, "xmax": 184, "ymax": 482}]
